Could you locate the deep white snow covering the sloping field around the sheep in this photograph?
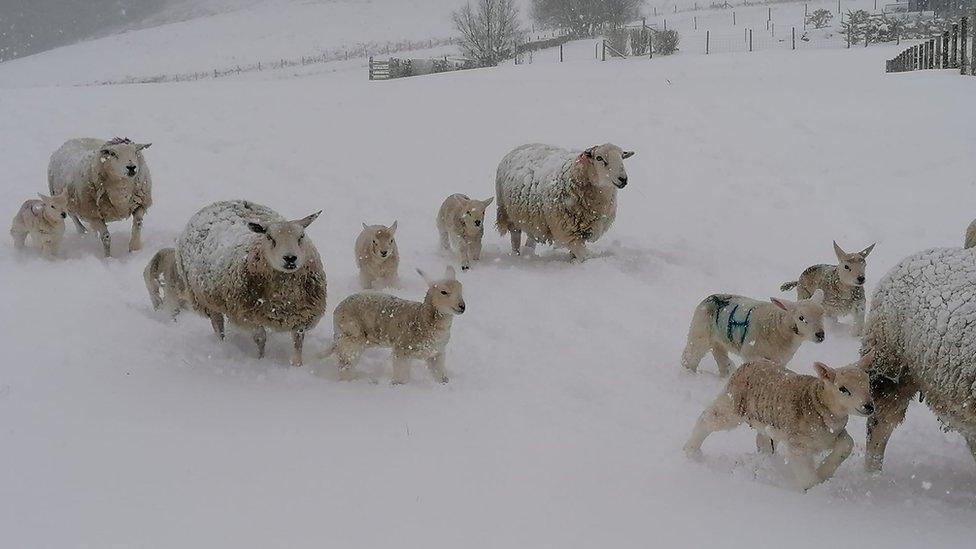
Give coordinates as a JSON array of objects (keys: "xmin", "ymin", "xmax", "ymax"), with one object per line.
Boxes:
[{"xmin": 0, "ymin": 3, "xmax": 976, "ymax": 549}]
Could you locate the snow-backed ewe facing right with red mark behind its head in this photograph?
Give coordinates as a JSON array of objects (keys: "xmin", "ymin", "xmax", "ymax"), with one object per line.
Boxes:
[{"xmin": 495, "ymin": 143, "xmax": 634, "ymax": 261}]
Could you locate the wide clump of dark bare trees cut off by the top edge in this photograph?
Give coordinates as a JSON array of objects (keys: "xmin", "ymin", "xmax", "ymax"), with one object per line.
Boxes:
[{"xmin": 532, "ymin": 0, "xmax": 644, "ymax": 36}]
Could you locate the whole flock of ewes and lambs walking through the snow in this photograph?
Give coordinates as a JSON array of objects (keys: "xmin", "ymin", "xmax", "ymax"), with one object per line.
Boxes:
[{"xmin": 10, "ymin": 138, "xmax": 976, "ymax": 490}]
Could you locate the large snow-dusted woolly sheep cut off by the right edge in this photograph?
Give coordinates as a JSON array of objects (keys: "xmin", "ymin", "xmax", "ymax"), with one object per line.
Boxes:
[{"xmin": 861, "ymin": 248, "xmax": 976, "ymax": 472}]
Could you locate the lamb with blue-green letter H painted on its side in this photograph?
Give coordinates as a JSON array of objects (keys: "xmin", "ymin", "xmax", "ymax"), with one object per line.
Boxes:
[{"xmin": 681, "ymin": 289, "xmax": 824, "ymax": 376}]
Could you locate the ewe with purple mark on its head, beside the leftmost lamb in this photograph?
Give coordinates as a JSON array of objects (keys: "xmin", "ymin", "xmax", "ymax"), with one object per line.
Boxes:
[{"xmin": 47, "ymin": 137, "xmax": 152, "ymax": 257}]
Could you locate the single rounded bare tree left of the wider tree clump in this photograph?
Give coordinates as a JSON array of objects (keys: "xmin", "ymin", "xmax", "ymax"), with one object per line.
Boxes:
[{"xmin": 451, "ymin": 0, "xmax": 522, "ymax": 67}]
